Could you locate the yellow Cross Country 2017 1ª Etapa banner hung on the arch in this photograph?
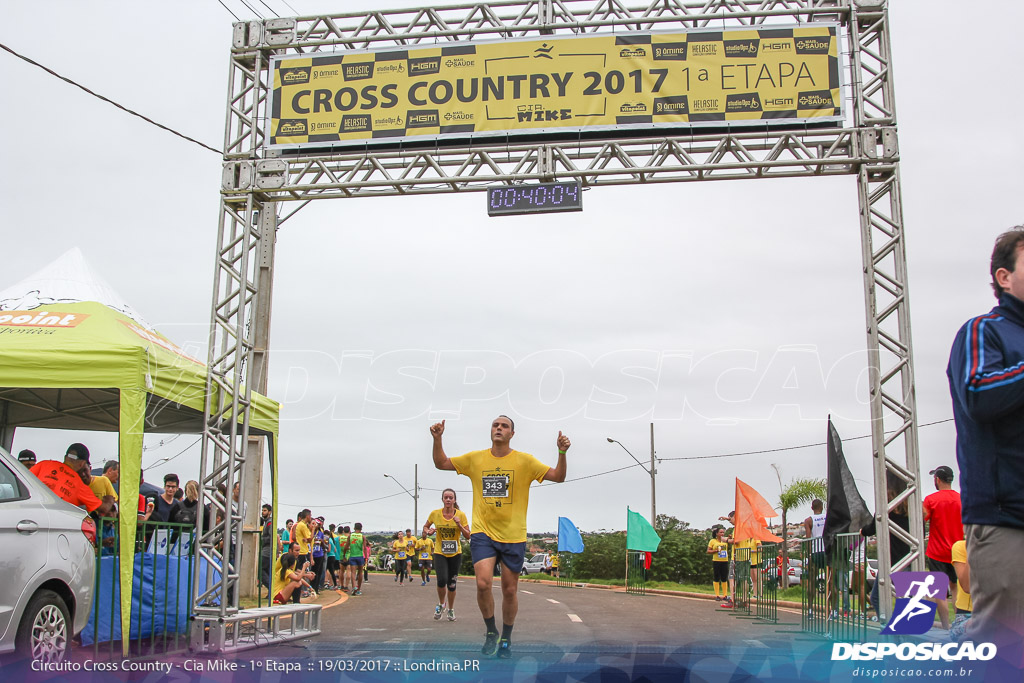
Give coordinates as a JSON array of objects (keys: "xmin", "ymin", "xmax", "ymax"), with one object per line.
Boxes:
[{"xmin": 268, "ymin": 25, "xmax": 843, "ymax": 147}]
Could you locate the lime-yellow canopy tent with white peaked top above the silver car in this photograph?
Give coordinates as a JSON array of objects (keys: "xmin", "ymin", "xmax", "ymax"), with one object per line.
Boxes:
[{"xmin": 0, "ymin": 249, "xmax": 280, "ymax": 653}]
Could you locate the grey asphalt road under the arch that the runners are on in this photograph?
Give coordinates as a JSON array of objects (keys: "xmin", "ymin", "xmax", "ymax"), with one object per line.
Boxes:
[{"xmin": 252, "ymin": 575, "xmax": 815, "ymax": 680}]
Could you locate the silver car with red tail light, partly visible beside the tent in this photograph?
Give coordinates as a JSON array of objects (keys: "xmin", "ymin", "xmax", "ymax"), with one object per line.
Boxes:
[{"xmin": 0, "ymin": 449, "xmax": 96, "ymax": 661}]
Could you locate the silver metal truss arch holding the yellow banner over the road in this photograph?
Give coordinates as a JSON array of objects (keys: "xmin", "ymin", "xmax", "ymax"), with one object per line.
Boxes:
[{"xmin": 193, "ymin": 0, "xmax": 924, "ymax": 649}]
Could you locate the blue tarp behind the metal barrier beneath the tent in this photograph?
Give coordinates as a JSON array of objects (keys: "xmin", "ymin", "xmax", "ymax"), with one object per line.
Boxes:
[{"xmin": 82, "ymin": 553, "xmax": 220, "ymax": 645}]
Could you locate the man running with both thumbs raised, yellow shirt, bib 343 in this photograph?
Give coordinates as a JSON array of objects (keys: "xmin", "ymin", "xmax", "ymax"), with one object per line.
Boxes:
[{"xmin": 430, "ymin": 415, "xmax": 571, "ymax": 658}]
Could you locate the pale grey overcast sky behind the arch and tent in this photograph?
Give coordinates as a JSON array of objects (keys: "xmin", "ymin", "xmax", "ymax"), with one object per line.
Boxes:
[{"xmin": 0, "ymin": 0, "xmax": 1024, "ymax": 531}]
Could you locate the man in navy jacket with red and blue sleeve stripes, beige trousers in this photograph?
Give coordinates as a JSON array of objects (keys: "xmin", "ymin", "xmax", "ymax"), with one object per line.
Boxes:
[{"xmin": 946, "ymin": 225, "xmax": 1024, "ymax": 663}]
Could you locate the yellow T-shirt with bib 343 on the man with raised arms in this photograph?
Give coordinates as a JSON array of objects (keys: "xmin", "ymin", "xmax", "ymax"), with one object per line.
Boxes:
[{"xmin": 451, "ymin": 449, "xmax": 551, "ymax": 543}]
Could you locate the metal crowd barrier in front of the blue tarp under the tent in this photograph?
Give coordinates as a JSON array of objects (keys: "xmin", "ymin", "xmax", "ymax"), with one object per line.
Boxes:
[{"xmin": 87, "ymin": 518, "xmax": 196, "ymax": 656}]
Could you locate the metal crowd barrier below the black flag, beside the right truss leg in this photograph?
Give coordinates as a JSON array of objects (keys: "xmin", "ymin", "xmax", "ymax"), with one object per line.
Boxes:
[{"xmin": 800, "ymin": 533, "xmax": 867, "ymax": 641}]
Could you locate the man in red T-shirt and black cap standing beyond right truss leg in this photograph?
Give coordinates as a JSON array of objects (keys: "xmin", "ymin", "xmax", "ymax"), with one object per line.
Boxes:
[{"xmin": 924, "ymin": 465, "xmax": 964, "ymax": 629}]
